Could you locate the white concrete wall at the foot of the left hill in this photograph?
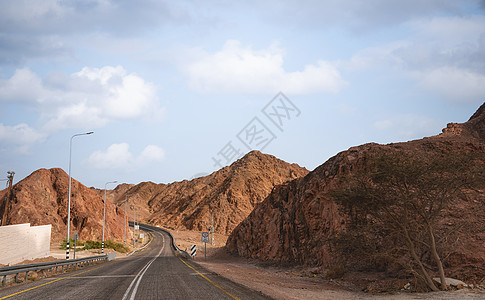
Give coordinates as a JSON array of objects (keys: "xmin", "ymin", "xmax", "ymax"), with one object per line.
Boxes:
[{"xmin": 0, "ymin": 223, "xmax": 52, "ymax": 265}]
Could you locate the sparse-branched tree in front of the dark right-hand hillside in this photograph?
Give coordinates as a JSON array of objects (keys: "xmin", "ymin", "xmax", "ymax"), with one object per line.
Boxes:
[{"xmin": 332, "ymin": 151, "xmax": 484, "ymax": 291}]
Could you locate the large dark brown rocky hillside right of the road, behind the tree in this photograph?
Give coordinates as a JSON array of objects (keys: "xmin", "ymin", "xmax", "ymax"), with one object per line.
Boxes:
[{"xmin": 226, "ymin": 104, "xmax": 485, "ymax": 284}]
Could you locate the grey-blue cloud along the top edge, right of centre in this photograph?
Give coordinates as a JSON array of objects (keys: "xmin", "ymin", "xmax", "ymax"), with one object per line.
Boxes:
[{"xmin": 241, "ymin": 0, "xmax": 466, "ymax": 34}]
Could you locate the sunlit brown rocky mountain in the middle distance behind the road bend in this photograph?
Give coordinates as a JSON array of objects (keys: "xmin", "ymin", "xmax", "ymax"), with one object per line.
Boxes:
[{"xmin": 115, "ymin": 151, "xmax": 308, "ymax": 234}]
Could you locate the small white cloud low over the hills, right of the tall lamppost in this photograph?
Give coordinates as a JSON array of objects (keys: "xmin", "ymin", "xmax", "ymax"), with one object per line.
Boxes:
[{"xmin": 87, "ymin": 143, "xmax": 165, "ymax": 170}]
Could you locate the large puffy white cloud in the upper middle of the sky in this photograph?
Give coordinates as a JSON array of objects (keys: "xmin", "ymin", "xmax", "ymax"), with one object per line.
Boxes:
[{"xmin": 184, "ymin": 40, "xmax": 346, "ymax": 94}]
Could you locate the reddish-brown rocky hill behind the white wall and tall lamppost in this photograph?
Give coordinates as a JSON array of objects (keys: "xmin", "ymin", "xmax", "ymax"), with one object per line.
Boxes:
[{"xmin": 0, "ymin": 168, "xmax": 124, "ymax": 241}]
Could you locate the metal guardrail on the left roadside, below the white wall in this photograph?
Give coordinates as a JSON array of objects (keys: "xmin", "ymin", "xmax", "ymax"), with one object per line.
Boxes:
[{"xmin": 0, "ymin": 254, "xmax": 108, "ymax": 286}]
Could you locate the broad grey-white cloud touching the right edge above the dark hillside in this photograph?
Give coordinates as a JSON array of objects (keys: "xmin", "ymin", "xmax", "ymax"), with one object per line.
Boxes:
[{"xmin": 340, "ymin": 16, "xmax": 485, "ymax": 103}]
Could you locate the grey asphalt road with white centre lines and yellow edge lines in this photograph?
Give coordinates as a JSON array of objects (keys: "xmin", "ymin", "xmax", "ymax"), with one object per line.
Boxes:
[{"xmin": 0, "ymin": 226, "xmax": 269, "ymax": 300}]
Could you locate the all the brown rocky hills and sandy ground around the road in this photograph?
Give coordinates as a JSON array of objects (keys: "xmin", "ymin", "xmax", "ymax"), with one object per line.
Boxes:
[{"xmin": 0, "ymin": 104, "xmax": 485, "ymax": 299}]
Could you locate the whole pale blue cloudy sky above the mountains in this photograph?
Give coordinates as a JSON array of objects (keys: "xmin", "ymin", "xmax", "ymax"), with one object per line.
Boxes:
[{"xmin": 0, "ymin": 0, "xmax": 485, "ymax": 188}]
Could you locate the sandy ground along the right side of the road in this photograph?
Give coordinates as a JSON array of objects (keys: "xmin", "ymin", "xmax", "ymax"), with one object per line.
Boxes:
[{"xmin": 172, "ymin": 230, "xmax": 485, "ymax": 300}]
